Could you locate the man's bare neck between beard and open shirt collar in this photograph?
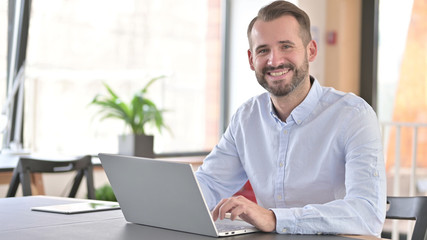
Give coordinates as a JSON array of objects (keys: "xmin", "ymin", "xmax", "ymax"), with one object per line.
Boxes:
[{"xmin": 270, "ymin": 76, "xmax": 311, "ymax": 122}]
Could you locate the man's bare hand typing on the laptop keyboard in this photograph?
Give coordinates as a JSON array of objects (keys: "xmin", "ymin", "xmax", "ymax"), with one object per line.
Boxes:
[{"xmin": 212, "ymin": 196, "xmax": 276, "ymax": 232}]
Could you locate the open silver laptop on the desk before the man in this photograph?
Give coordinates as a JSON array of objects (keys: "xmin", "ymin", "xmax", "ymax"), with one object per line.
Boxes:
[{"xmin": 98, "ymin": 153, "xmax": 258, "ymax": 237}]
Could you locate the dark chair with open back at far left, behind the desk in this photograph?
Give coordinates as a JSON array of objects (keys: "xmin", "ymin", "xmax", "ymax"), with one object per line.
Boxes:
[{"xmin": 6, "ymin": 155, "xmax": 95, "ymax": 199}]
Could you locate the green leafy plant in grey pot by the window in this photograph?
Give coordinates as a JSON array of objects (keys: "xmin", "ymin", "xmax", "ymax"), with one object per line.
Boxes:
[{"xmin": 91, "ymin": 76, "xmax": 166, "ymax": 157}]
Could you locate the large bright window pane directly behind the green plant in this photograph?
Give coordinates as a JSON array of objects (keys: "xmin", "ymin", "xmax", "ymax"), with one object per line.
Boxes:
[{"xmin": 13, "ymin": 0, "xmax": 221, "ymax": 154}]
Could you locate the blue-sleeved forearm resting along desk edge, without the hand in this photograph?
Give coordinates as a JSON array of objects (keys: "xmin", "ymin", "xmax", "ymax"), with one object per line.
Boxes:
[{"xmin": 271, "ymin": 198, "xmax": 385, "ymax": 236}]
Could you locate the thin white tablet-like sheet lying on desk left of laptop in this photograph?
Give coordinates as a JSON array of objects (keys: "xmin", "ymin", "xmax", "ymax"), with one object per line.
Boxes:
[{"xmin": 31, "ymin": 202, "xmax": 120, "ymax": 214}]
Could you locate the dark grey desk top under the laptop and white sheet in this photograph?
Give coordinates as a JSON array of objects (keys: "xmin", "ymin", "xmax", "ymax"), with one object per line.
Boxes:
[{"xmin": 0, "ymin": 196, "xmax": 377, "ymax": 240}]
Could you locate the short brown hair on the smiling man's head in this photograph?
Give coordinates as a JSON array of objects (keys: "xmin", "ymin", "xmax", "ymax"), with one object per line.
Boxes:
[{"xmin": 247, "ymin": 0, "xmax": 312, "ymax": 46}]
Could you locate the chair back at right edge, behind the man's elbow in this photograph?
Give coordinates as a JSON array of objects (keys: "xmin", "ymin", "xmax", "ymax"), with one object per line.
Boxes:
[{"xmin": 386, "ymin": 196, "xmax": 427, "ymax": 240}]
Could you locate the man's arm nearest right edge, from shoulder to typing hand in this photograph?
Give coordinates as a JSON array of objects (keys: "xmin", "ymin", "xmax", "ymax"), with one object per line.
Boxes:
[{"xmin": 209, "ymin": 104, "xmax": 386, "ymax": 236}]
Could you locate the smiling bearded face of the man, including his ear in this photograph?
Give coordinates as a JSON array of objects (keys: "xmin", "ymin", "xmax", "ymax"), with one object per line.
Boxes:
[{"xmin": 248, "ymin": 16, "xmax": 317, "ymax": 97}]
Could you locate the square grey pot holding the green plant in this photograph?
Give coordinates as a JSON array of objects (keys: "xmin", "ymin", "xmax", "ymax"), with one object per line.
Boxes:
[{"xmin": 119, "ymin": 135, "xmax": 154, "ymax": 158}]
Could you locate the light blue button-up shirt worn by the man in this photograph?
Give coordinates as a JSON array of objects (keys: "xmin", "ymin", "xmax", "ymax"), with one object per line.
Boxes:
[{"xmin": 196, "ymin": 78, "xmax": 386, "ymax": 236}]
